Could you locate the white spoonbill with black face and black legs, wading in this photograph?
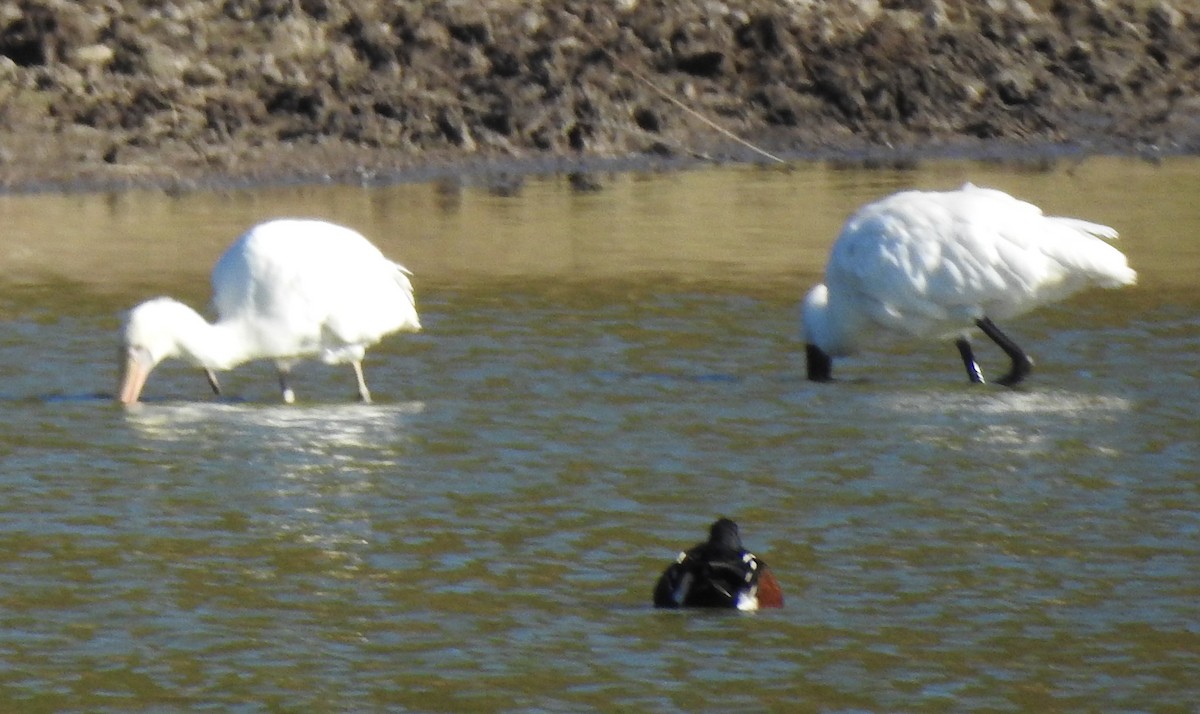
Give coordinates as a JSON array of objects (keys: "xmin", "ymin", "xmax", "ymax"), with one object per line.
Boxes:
[{"xmin": 802, "ymin": 184, "xmax": 1138, "ymax": 386}]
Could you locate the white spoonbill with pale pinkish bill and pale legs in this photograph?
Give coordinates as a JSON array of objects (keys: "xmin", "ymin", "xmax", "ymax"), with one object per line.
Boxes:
[{"xmin": 118, "ymin": 218, "xmax": 421, "ymax": 404}]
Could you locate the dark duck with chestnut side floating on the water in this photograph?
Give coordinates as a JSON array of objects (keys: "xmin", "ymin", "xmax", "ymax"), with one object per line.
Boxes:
[{"xmin": 654, "ymin": 518, "xmax": 784, "ymax": 610}]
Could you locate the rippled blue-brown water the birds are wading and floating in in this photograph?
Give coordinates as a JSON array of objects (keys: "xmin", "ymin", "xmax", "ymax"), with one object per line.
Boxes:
[{"xmin": 0, "ymin": 160, "xmax": 1200, "ymax": 712}]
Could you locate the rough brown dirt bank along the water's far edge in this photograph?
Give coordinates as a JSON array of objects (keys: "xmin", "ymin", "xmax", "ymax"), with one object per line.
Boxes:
[{"xmin": 0, "ymin": 0, "xmax": 1200, "ymax": 188}]
